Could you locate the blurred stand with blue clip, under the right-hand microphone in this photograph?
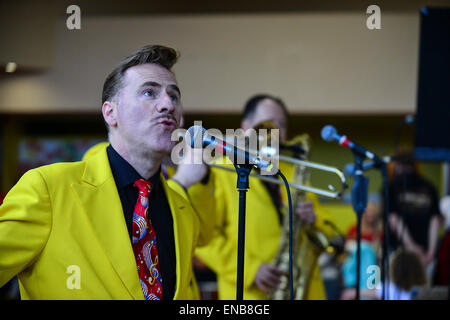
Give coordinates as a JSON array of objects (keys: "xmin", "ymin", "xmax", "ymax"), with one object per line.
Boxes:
[{"xmin": 352, "ymin": 152, "xmax": 369, "ymax": 300}]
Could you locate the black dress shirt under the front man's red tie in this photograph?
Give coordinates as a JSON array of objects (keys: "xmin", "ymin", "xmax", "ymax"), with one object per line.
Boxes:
[{"xmin": 107, "ymin": 145, "xmax": 176, "ymax": 300}]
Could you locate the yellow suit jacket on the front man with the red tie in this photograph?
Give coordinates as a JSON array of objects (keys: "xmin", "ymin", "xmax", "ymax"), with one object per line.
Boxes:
[{"xmin": 0, "ymin": 146, "xmax": 211, "ymax": 299}]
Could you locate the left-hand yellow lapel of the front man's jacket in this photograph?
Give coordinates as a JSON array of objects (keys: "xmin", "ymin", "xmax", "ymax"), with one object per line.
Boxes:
[{"xmin": 72, "ymin": 147, "xmax": 144, "ymax": 299}]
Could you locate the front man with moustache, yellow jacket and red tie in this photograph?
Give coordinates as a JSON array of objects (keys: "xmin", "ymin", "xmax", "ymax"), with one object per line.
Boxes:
[{"xmin": 0, "ymin": 46, "xmax": 215, "ymax": 299}]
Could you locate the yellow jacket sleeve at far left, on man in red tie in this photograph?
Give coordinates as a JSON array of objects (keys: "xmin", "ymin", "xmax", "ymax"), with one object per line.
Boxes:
[{"xmin": 0, "ymin": 170, "xmax": 51, "ymax": 287}]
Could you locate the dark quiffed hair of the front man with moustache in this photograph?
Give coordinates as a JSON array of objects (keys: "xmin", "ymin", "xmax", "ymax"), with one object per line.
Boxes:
[{"xmin": 102, "ymin": 45, "xmax": 179, "ymax": 104}]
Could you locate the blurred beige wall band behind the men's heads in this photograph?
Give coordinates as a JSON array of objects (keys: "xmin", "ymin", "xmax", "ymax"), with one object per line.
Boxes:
[{"xmin": 0, "ymin": 11, "xmax": 419, "ymax": 114}]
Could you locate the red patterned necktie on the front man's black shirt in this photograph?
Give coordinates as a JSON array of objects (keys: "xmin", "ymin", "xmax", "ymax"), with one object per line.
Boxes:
[{"xmin": 133, "ymin": 179, "xmax": 163, "ymax": 300}]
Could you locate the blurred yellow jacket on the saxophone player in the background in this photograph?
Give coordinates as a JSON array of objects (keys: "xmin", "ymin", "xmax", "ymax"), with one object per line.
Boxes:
[{"xmin": 188, "ymin": 163, "xmax": 333, "ymax": 300}]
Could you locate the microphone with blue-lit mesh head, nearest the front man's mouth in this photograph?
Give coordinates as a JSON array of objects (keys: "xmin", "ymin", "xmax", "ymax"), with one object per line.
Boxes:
[{"xmin": 185, "ymin": 126, "xmax": 271, "ymax": 169}]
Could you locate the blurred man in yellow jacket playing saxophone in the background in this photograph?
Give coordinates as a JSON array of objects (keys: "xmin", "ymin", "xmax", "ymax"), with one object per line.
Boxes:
[{"xmin": 176, "ymin": 95, "xmax": 333, "ymax": 299}]
